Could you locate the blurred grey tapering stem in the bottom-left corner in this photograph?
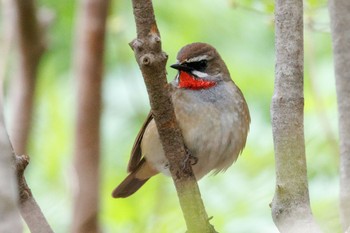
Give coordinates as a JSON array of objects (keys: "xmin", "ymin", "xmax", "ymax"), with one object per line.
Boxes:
[{"xmin": 0, "ymin": 93, "xmax": 22, "ymax": 233}]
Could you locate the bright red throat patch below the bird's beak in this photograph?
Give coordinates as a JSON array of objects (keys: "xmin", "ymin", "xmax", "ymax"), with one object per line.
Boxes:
[{"xmin": 179, "ymin": 71, "xmax": 216, "ymax": 90}]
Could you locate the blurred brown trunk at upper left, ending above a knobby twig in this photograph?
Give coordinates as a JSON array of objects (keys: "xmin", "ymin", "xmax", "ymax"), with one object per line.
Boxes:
[{"xmin": 9, "ymin": 0, "xmax": 44, "ymax": 154}]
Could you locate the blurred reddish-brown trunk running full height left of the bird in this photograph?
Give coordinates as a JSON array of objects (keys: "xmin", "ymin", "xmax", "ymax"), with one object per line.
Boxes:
[{"xmin": 72, "ymin": 0, "xmax": 108, "ymax": 233}]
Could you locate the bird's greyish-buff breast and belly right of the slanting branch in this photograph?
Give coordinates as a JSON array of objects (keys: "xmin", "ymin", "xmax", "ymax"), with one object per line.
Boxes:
[{"xmin": 172, "ymin": 83, "xmax": 248, "ymax": 179}]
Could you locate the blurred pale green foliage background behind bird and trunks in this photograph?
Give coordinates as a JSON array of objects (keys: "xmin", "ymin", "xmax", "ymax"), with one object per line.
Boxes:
[{"xmin": 0, "ymin": 0, "xmax": 340, "ymax": 233}]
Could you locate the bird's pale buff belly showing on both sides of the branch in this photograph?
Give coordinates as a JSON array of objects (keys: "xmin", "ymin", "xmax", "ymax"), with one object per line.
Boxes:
[{"xmin": 141, "ymin": 83, "xmax": 249, "ymax": 179}]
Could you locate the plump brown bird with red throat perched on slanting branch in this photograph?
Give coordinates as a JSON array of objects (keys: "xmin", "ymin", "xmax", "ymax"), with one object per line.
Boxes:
[{"xmin": 112, "ymin": 42, "xmax": 250, "ymax": 198}]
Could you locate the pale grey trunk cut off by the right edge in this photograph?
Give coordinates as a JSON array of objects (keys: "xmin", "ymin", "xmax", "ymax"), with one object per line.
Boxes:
[{"xmin": 329, "ymin": 0, "xmax": 350, "ymax": 230}]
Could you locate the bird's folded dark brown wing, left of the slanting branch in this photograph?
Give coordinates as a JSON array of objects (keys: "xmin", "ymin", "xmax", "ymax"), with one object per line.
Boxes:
[{"xmin": 128, "ymin": 112, "xmax": 153, "ymax": 172}]
